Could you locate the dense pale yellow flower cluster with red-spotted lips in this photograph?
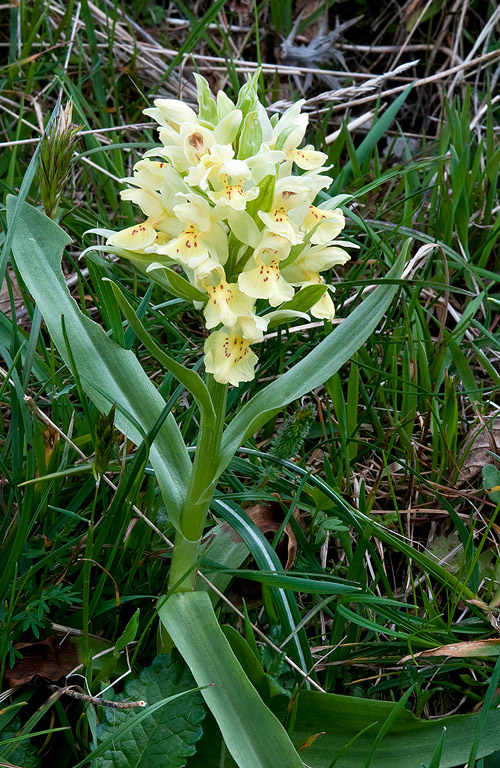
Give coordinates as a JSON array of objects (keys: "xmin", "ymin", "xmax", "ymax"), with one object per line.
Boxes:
[{"xmin": 107, "ymin": 76, "xmax": 349, "ymax": 385}]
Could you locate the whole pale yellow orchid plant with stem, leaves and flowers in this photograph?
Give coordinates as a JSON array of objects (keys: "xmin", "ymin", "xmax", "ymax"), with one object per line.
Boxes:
[{"xmin": 8, "ymin": 73, "xmax": 406, "ymax": 768}]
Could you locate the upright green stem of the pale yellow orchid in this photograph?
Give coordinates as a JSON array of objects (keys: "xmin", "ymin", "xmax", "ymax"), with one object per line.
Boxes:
[{"xmin": 168, "ymin": 375, "xmax": 227, "ymax": 592}]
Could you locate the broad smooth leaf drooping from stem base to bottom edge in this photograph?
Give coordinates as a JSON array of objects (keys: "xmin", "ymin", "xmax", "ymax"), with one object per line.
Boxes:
[{"xmin": 159, "ymin": 592, "xmax": 304, "ymax": 768}]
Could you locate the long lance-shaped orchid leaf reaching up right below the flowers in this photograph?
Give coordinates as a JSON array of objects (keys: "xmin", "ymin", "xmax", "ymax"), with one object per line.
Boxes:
[{"xmin": 217, "ymin": 240, "xmax": 411, "ymax": 475}]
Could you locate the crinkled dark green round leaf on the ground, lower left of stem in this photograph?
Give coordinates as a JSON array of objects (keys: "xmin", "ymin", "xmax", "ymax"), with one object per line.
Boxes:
[{"xmin": 97, "ymin": 654, "xmax": 205, "ymax": 768}]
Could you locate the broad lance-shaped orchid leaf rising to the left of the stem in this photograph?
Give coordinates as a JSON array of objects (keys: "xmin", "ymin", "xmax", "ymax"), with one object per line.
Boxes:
[{"xmin": 7, "ymin": 195, "xmax": 191, "ymax": 525}]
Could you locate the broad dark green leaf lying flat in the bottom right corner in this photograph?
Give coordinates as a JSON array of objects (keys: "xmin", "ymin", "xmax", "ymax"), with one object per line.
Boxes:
[{"xmin": 293, "ymin": 691, "xmax": 500, "ymax": 768}]
